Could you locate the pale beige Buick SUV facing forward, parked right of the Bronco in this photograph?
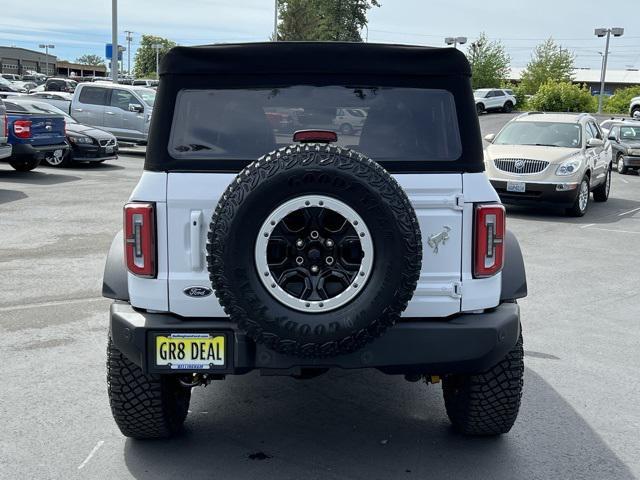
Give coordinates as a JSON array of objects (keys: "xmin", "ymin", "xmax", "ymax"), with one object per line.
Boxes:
[{"xmin": 484, "ymin": 112, "xmax": 613, "ymax": 216}]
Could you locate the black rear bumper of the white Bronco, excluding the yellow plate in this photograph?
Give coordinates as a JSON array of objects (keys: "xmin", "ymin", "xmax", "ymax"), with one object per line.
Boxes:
[{"xmin": 109, "ymin": 301, "xmax": 520, "ymax": 375}]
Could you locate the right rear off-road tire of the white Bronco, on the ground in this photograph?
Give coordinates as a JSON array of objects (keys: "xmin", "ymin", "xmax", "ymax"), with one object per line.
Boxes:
[{"xmin": 442, "ymin": 335, "xmax": 524, "ymax": 435}]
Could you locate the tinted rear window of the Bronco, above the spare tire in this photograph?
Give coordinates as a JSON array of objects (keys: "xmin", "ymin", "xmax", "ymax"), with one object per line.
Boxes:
[{"xmin": 169, "ymin": 85, "xmax": 462, "ymax": 162}]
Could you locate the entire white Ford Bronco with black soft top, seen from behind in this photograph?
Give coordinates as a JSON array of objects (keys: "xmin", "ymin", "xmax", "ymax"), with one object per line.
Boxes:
[{"xmin": 103, "ymin": 42, "xmax": 527, "ymax": 438}]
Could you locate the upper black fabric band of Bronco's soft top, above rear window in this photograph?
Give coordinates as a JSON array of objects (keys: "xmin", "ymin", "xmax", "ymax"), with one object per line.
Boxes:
[{"xmin": 160, "ymin": 42, "xmax": 471, "ymax": 77}]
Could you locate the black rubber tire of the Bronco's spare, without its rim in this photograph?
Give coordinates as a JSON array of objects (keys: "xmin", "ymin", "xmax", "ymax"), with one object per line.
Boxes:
[{"xmin": 207, "ymin": 144, "xmax": 422, "ymax": 358}]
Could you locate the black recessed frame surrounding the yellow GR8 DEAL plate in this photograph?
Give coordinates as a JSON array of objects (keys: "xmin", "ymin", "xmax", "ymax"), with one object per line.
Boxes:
[{"xmin": 147, "ymin": 330, "xmax": 233, "ymax": 374}]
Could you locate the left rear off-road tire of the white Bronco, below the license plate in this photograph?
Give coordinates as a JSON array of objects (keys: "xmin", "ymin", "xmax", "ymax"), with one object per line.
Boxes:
[{"xmin": 107, "ymin": 338, "xmax": 191, "ymax": 439}]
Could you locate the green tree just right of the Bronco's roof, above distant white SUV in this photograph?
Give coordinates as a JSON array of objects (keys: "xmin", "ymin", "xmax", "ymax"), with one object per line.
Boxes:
[{"xmin": 467, "ymin": 33, "xmax": 511, "ymax": 89}]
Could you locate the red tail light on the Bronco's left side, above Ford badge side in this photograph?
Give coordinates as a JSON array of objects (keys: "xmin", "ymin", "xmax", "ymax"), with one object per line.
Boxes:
[{"xmin": 124, "ymin": 203, "xmax": 157, "ymax": 278}]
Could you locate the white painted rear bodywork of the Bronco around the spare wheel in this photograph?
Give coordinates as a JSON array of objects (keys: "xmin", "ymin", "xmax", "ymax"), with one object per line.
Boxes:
[{"xmin": 129, "ymin": 172, "xmax": 501, "ymax": 317}]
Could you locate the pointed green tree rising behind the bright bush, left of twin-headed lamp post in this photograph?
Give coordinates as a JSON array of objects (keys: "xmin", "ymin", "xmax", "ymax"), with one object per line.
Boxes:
[{"xmin": 521, "ymin": 38, "xmax": 575, "ymax": 95}]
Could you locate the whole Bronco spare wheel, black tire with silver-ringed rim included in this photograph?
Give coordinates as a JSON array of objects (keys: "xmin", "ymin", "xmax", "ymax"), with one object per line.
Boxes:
[{"xmin": 207, "ymin": 144, "xmax": 422, "ymax": 357}]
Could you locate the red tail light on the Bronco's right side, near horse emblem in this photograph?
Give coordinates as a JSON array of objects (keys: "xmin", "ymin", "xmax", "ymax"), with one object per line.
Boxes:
[{"xmin": 473, "ymin": 204, "xmax": 506, "ymax": 278}]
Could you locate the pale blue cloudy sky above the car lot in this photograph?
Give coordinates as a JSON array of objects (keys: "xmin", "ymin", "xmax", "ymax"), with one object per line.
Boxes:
[{"xmin": 0, "ymin": 0, "xmax": 640, "ymax": 69}]
